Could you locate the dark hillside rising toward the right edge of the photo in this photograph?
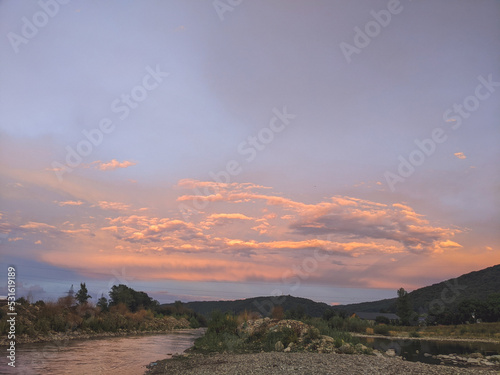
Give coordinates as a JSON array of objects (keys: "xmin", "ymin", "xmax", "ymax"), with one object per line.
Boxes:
[{"xmin": 334, "ymin": 265, "xmax": 500, "ymax": 312}]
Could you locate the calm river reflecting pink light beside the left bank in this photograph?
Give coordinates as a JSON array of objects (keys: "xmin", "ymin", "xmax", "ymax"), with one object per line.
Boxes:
[{"xmin": 0, "ymin": 328, "xmax": 204, "ymax": 375}]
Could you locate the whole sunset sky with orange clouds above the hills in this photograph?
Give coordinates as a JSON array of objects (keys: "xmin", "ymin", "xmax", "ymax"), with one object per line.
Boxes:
[{"xmin": 0, "ymin": 0, "xmax": 500, "ymax": 304}]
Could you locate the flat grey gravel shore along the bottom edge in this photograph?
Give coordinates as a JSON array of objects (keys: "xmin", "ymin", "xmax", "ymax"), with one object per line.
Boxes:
[{"xmin": 147, "ymin": 352, "xmax": 498, "ymax": 375}]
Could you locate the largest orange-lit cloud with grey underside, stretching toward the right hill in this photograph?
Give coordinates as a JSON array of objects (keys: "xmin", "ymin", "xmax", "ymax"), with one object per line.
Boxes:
[{"xmin": 178, "ymin": 180, "xmax": 460, "ymax": 252}]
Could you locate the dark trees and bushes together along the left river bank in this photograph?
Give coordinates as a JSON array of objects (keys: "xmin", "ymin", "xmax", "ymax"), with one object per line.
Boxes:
[{"xmin": 0, "ymin": 283, "xmax": 206, "ymax": 345}]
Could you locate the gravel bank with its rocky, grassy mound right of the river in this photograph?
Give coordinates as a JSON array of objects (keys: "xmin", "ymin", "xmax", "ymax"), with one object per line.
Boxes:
[{"xmin": 148, "ymin": 312, "xmax": 500, "ymax": 374}]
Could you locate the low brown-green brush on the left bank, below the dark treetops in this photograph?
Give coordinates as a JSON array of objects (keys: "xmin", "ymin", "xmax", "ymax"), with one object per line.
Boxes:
[{"xmin": 0, "ymin": 290, "xmax": 204, "ymax": 345}]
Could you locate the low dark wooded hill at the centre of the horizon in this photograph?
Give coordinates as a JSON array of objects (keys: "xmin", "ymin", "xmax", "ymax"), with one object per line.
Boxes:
[{"xmin": 162, "ymin": 295, "xmax": 332, "ymax": 318}]
